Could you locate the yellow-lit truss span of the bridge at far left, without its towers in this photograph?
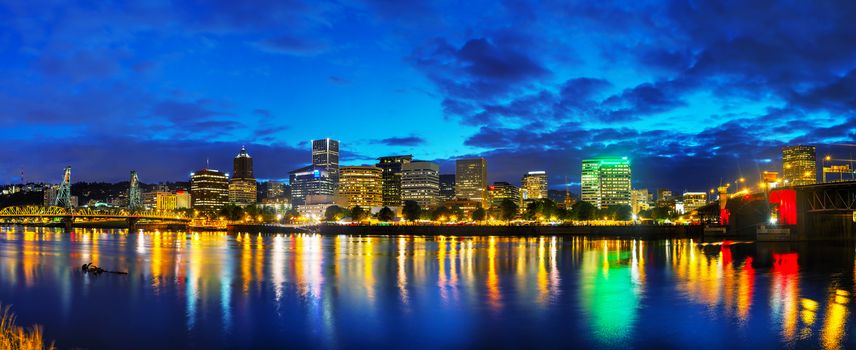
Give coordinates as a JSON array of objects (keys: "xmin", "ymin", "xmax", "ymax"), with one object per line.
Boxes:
[{"xmin": 0, "ymin": 205, "xmax": 191, "ymax": 228}]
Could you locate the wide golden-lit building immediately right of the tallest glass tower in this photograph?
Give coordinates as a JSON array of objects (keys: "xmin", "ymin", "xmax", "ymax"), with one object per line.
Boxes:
[{"xmin": 337, "ymin": 166, "xmax": 383, "ymax": 208}]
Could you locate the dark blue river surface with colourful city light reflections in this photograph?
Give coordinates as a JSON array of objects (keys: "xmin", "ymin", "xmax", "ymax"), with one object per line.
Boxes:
[{"xmin": 0, "ymin": 227, "xmax": 856, "ymax": 349}]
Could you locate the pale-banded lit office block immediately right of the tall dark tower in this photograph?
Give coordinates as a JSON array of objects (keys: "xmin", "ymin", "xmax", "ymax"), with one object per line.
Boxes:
[{"xmin": 401, "ymin": 162, "xmax": 440, "ymax": 208}]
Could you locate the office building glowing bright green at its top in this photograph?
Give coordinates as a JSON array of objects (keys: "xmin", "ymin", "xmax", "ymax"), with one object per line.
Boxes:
[{"xmin": 580, "ymin": 157, "xmax": 631, "ymax": 208}]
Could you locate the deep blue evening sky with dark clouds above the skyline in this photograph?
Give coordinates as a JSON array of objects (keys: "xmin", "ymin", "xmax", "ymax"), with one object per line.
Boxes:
[{"xmin": 0, "ymin": 0, "xmax": 856, "ymax": 191}]
